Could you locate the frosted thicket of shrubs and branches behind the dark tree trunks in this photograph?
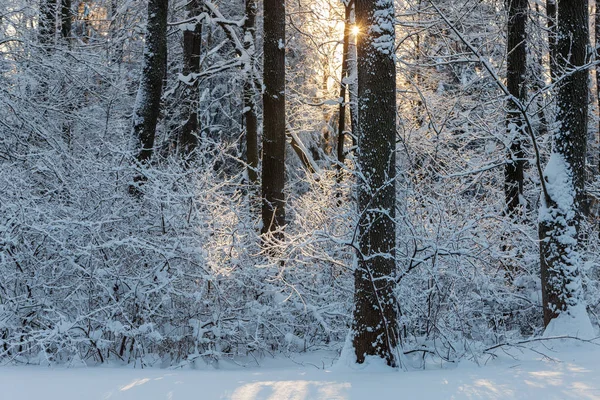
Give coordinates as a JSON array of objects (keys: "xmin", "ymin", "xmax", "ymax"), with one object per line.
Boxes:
[{"xmin": 0, "ymin": 0, "xmax": 600, "ymax": 366}]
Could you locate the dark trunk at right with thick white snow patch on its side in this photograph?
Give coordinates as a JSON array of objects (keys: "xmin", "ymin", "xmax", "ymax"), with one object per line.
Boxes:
[{"xmin": 539, "ymin": 0, "xmax": 589, "ymax": 325}]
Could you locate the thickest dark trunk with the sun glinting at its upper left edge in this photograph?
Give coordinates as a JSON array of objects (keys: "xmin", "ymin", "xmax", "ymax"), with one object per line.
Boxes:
[{"xmin": 353, "ymin": 0, "xmax": 398, "ymax": 366}]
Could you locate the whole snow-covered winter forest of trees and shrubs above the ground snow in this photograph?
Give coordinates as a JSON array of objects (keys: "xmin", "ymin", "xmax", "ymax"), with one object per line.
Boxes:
[{"xmin": 0, "ymin": 0, "xmax": 600, "ymax": 382}]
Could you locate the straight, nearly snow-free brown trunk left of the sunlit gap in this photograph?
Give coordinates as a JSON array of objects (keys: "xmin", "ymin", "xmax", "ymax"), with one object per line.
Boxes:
[{"xmin": 262, "ymin": 0, "xmax": 286, "ymax": 233}]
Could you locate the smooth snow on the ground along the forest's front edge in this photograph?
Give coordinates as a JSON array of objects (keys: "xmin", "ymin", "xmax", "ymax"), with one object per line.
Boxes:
[{"xmin": 0, "ymin": 341, "xmax": 600, "ymax": 400}]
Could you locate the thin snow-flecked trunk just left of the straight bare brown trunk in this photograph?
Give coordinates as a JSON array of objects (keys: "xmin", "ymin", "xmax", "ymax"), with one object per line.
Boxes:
[{"xmin": 243, "ymin": 0, "xmax": 258, "ymax": 184}]
